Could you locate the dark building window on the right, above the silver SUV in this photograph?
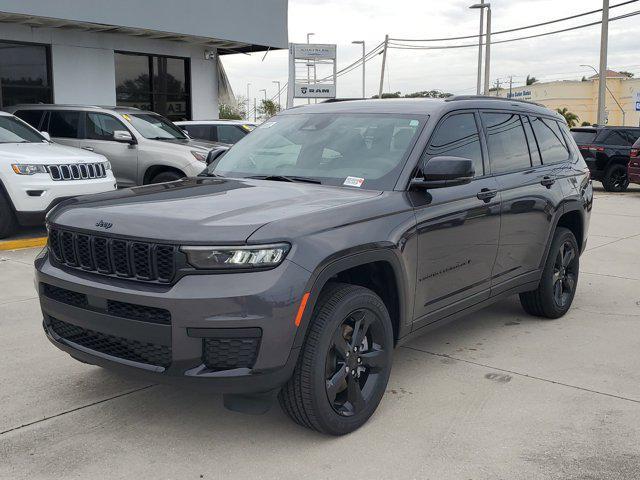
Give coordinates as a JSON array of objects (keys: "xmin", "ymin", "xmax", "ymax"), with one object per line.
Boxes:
[{"xmin": 115, "ymin": 52, "xmax": 191, "ymax": 120}]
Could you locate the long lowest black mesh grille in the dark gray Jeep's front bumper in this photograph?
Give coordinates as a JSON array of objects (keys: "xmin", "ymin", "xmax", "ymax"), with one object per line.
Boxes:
[{"xmin": 49, "ymin": 317, "xmax": 171, "ymax": 368}]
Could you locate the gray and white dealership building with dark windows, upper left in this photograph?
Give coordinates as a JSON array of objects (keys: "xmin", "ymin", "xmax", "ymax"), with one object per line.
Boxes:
[{"xmin": 0, "ymin": 0, "xmax": 288, "ymax": 120}]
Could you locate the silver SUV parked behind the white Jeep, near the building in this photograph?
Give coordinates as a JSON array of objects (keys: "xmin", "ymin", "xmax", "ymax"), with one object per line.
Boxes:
[{"xmin": 8, "ymin": 105, "xmax": 225, "ymax": 187}]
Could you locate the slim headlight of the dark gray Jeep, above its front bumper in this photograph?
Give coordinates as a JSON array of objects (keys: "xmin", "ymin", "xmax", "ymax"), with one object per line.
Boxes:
[{"xmin": 182, "ymin": 243, "xmax": 290, "ymax": 270}]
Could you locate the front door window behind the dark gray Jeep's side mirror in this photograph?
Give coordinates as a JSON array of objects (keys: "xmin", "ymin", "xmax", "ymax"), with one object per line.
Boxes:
[{"xmin": 426, "ymin": 113, "xmax": 484, "ymax": 177}]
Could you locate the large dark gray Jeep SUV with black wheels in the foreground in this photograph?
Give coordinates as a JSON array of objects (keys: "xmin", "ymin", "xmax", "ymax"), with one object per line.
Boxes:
[{"xmin": 35, "ymin": 97, "xmax": 593, "ymax": 435}]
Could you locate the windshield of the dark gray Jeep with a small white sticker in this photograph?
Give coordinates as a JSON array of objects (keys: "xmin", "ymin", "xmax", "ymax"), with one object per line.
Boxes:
[{"xmin": 207, "ymin": 113, "xmax": 427, "ymax": 190}]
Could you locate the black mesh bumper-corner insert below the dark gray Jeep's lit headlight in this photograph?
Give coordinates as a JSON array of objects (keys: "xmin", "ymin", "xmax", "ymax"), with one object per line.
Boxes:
[{"xmin": 202, "ymin": 338, "xmax": 260, "ymax": 371}]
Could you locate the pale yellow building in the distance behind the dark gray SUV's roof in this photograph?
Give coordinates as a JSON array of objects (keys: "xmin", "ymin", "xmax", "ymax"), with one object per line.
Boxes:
[{"xmin": 492, "ymin": 70, "xmax": 640, "ymax": 126}]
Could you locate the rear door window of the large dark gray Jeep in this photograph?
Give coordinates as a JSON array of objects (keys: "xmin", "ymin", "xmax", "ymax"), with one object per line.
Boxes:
[{"xmin": 482, "ymin": 113, "xmax": 531, "ymax": 173}]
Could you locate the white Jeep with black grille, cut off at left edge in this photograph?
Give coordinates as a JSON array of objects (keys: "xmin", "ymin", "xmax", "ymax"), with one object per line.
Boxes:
[{"xmin": 0, "ymin": 112, "xmax": 116, "ymax": 238}]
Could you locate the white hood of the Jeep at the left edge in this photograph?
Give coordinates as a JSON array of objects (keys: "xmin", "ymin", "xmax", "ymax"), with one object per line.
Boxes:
[{"xmin": 0, "ymin": 142, "xmax": 107, "ymax": 165}]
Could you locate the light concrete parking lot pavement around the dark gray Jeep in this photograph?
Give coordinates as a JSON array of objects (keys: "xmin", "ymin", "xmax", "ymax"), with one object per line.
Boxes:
[{"xmin": 0, "ymin": 185, "xmax": 640, "ymax": 480}]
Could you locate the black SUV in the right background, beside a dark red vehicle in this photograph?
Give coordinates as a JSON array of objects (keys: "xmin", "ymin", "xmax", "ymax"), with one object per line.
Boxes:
[{"xmin": 571, "ymin": 126, "xmax": 640, "ymax": 192}]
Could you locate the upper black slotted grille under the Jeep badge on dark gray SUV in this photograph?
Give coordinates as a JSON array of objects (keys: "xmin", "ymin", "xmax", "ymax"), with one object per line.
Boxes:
[{"xmin": 49, "ymin": 228, "xmax": 176, "ymax": 283}]
